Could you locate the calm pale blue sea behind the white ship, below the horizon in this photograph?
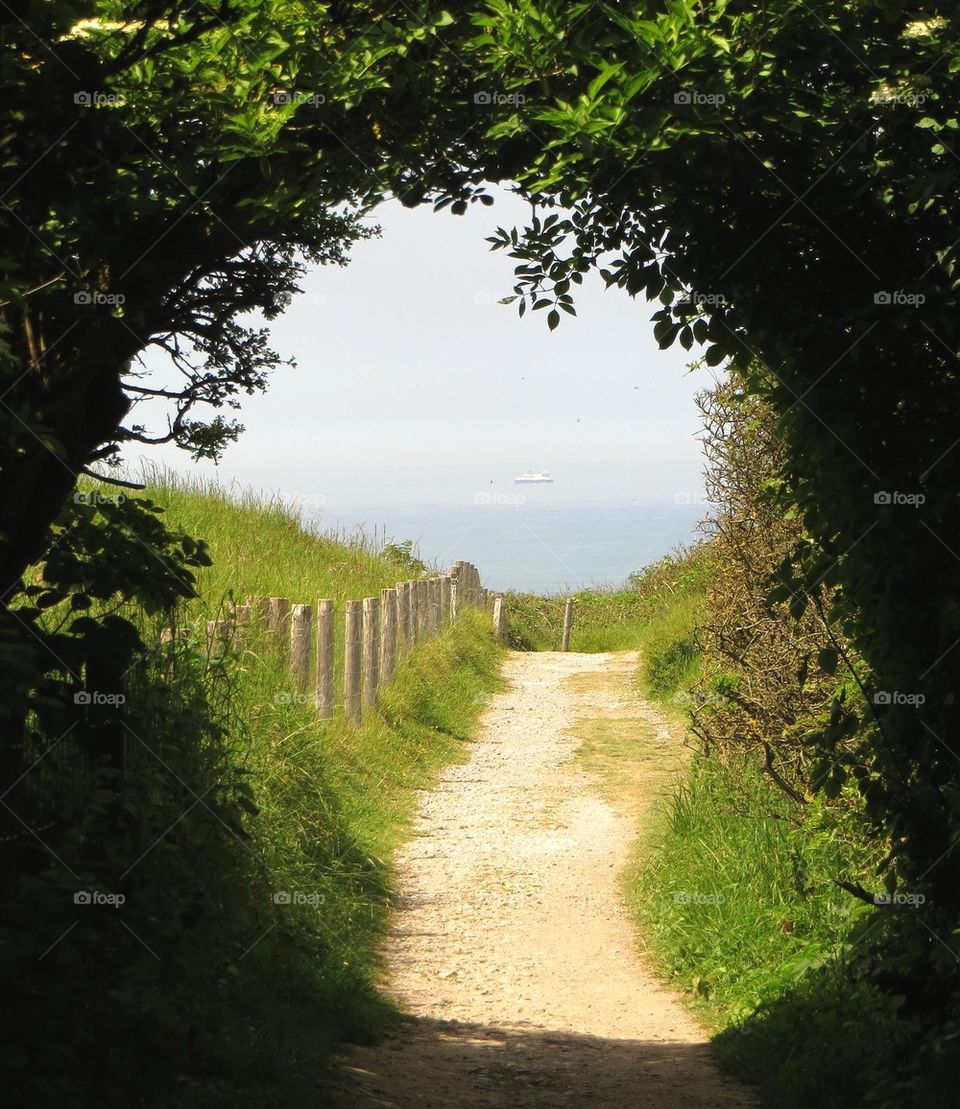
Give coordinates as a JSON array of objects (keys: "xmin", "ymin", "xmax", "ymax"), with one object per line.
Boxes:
[{"xmin": 226, "ymin": 462, "xmax": 706, "ymax": 592}]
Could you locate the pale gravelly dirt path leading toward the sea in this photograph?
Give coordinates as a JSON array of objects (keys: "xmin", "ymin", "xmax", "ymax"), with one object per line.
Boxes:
[{"xmin": 335, "ymin": 652, "xmax": 754, "ymax": 1109}]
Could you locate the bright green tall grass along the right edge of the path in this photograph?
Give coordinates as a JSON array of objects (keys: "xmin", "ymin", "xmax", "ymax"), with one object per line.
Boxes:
[{"xmin": 627, "ymin": 757, "xmax": 897, "ymax": 1109}]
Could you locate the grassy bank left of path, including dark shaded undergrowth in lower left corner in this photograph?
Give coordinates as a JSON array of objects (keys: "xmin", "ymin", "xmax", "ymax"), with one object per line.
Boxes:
[{"xmin": 0, "ymin": 487, "xmax": 501, "ymax": 1109}]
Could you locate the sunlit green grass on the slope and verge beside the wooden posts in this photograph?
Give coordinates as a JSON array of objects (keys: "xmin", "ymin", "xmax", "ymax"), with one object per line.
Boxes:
[{"xmin": 83, "ymin": 472, "xmax": 502, "ymax": 1107}]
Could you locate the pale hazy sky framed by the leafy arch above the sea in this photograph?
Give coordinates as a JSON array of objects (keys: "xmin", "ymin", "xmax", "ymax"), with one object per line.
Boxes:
[{"xmin": 140, "ymin": 185, "xmax": 706, "ymax": 478}]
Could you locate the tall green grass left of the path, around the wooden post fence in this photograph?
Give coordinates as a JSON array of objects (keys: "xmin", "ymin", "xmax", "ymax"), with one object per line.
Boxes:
[{"xmin": 52, "ymin": 475, "xmax": 502, "ymax": 1109}]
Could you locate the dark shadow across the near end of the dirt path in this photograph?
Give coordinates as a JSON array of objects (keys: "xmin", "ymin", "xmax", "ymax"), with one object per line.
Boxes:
[{"xmin": 323, "ymin": 1019, "xmax": 756, "ymax": 1109}]
